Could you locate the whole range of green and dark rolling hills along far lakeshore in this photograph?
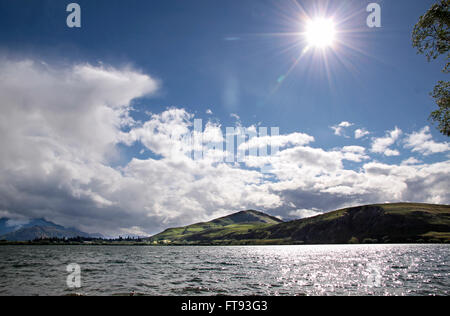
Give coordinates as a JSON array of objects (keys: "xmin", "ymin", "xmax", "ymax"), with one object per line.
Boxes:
[{"xmin": 150, "ymin": 203, "xmax": 450, "ymax": 245}]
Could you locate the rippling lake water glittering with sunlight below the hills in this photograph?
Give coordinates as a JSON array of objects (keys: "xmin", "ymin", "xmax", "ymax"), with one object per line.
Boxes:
[{"xmin": 0, "ymin": 245, "xmax": 450, "ymax": 296}]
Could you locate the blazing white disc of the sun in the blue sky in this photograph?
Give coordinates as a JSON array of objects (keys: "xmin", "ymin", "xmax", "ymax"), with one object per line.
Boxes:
[{"xmin": 305, "ymin": 18, "xmax": 336, "ymax": 48}]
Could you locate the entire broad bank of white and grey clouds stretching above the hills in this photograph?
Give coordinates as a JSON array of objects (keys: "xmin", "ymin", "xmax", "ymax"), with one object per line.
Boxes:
[{"xmin": 0, "ymin": 60, "xmax": 450, "ymax": 236}]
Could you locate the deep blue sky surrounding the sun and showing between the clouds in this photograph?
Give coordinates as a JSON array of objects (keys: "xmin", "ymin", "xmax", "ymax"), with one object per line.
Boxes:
[{"xmin": 0, "ymin": 0, "xmax": 449, "ymax": 232}]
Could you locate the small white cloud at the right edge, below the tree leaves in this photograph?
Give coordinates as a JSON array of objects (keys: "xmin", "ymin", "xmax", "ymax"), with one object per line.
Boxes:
[{"xmin": 405, "ymin": 126, "xmax": 450, "ymax": 156}]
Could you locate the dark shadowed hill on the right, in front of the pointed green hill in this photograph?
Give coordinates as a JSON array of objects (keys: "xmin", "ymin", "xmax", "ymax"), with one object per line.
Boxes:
[{"xmin": 242, "ymin": 203, "xmax": 450, "ymax": 244}]
